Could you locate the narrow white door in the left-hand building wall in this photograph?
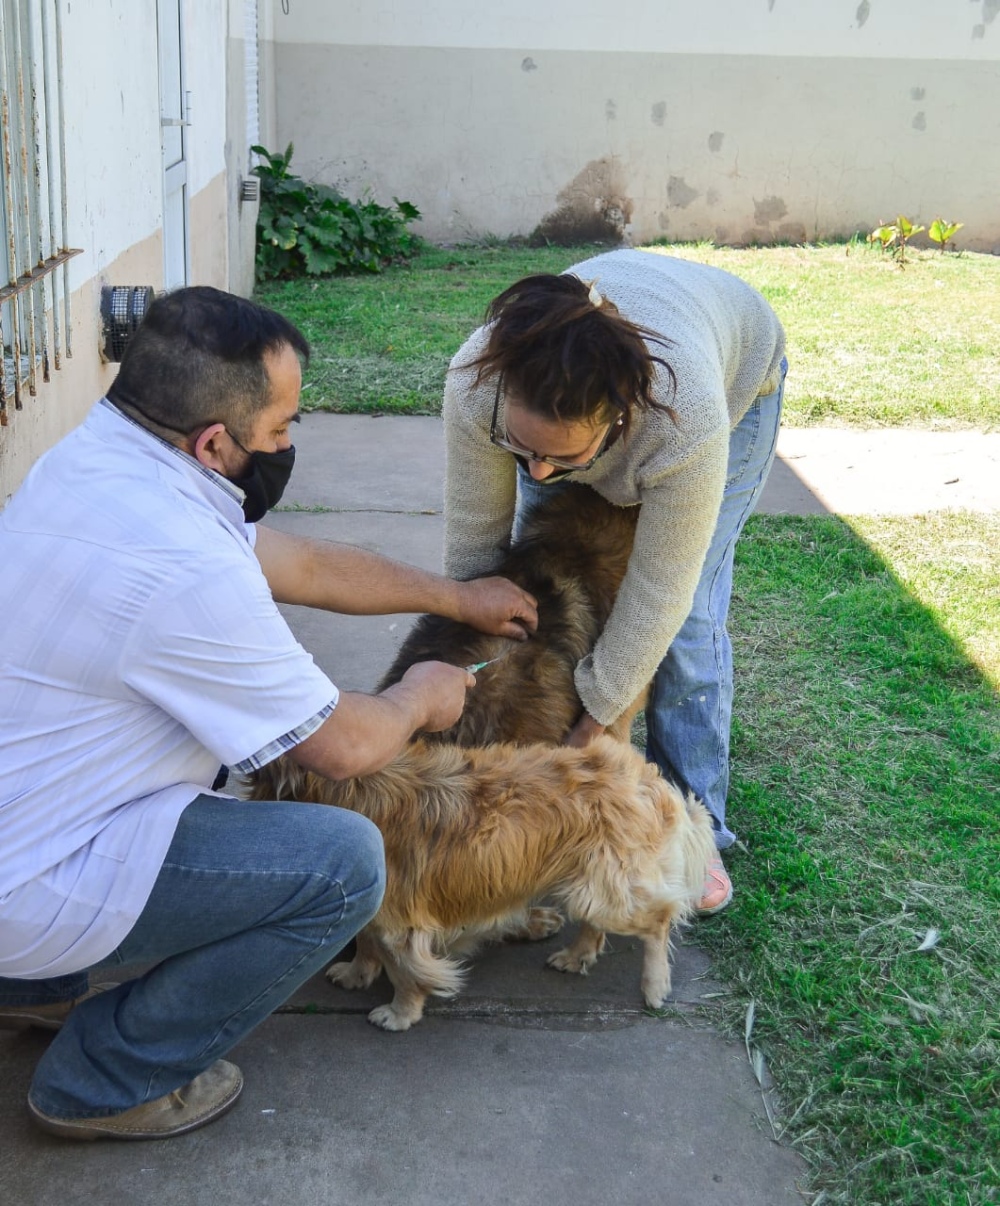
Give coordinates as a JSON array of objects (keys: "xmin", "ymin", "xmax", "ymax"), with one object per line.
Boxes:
[{"xmin": 157, "ymin": 0, "xmax": 188, "ymax": 289}]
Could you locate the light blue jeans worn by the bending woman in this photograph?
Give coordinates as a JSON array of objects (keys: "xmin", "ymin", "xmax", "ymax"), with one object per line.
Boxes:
[{"xmin": 517, "ymin": 366, "xmax": 784, "ymax": 850}]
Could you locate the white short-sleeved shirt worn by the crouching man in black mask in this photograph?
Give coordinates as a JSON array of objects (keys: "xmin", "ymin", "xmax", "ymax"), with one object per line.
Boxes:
[{"xmin": 0, "ymin": 400, "xmax": 338, "ymax": 978}]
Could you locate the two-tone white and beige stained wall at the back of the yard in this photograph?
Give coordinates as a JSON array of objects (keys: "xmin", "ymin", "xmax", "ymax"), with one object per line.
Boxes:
[{"xmin": 262, "ymin": 0, "xmax": 1000, "ymax": 250}]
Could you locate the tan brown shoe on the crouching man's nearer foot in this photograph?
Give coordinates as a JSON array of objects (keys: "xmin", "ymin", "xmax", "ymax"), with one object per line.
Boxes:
[{"xmin": 28, "ymin": 1059, "xmax": 242, "ymax": 1140}]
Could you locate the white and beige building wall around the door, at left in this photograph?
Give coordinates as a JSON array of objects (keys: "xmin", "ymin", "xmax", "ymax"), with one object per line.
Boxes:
[{"xmin": 0, "ymin": 0, "xmax": 255, "ymax": 507}]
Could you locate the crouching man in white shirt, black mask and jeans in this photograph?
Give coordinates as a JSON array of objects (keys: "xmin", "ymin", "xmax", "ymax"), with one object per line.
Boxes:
[{"xmin": 0, "ymin": 287, "xmax": 537, "ymax": 1138}]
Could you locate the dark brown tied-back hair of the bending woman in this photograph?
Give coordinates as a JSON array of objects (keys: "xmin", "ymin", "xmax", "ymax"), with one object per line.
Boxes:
[{"xmin": 463, "ymin": 273, "xmax": 677, "ymax": 429}]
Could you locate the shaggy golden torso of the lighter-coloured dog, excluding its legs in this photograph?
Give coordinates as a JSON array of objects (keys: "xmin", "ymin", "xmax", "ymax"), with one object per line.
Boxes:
[{"xmin": 252, "ymin": 737, "xmax": 714, "ymax": 937}]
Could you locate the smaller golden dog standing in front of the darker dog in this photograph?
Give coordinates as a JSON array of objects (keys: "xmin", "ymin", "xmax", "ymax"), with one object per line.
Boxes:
[{"xmin": 253, "ymin": 737, "xmax": 715, "ymax": 1030}]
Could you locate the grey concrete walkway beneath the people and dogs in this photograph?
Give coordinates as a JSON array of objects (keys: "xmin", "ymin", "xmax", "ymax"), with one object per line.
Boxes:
[{"xmin": 0, "ymin": 415, "xmax": 1000, "ymax": 1206}]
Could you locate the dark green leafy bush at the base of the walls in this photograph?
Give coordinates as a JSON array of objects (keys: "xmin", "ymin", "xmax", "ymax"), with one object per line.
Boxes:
[{"xmin": 251, "ymin": 142, "xmax": 420, "ymax": 281}]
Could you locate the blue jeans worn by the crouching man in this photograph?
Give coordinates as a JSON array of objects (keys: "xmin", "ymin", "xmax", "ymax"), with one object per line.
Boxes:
[{"xmin": 0, "ymin": 796, "xmax": 385, "ymax": 1118}]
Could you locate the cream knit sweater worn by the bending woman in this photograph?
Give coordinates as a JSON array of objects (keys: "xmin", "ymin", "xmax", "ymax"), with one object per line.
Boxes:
[{"xmin": 444, "ymin": 251, "xmax": 785, "ymax": 725}]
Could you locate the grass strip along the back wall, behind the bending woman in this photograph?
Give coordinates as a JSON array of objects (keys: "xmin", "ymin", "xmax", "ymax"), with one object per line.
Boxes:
[{"xmin": 256, "ymin": 244, "xmax": 1000, "ymax": 428}]
